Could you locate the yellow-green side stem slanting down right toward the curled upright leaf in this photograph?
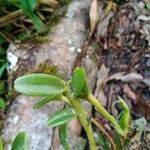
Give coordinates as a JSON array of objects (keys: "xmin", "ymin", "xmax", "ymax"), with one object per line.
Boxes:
[{"xmin": 87, "ymin": 93, "xmax": 125, "ymax": 136}]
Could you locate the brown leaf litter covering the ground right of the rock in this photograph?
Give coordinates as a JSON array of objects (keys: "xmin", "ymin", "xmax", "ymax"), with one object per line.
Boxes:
[{"xmin": 90, "ymin": 0, "xmax": 150, "ymax": 150}]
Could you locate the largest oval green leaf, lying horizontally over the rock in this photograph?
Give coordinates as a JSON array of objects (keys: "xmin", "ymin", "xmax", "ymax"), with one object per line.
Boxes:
[{"xmin": 14, "ymin": 74, "xmax": 66, "ymax": 97}]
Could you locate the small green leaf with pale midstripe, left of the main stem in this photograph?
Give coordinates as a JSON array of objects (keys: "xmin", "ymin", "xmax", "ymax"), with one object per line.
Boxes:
[{"xmin": 48, "ymin": 108, "xmax": 77, "ymax": 127}]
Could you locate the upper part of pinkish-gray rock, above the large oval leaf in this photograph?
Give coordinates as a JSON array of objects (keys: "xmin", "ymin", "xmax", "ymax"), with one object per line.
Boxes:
[{"xmin": 8, "ymin": 0, "xmax": 90, "ymax": 77}]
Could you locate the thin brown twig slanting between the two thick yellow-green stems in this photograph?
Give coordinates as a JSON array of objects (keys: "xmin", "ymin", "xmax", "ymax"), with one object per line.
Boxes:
[{"xmin": 91, "ymin": 118, "xmax": 116, "ymax": 150}]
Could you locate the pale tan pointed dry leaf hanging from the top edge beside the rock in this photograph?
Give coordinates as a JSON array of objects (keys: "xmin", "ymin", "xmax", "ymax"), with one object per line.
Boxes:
[{"xmin": 89, "ymin": 0, "xmax": 98, "ymax": 35}]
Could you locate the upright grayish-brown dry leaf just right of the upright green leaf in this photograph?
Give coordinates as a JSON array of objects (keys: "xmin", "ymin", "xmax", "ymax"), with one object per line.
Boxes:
[{"xmin": 94, "ymin": 65, "xmax": 109, "ymax": 106}]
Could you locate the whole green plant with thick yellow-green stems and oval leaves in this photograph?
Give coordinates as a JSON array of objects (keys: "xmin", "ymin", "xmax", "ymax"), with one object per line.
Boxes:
[{"xmin": 14, "ymin": 67, "xmax": 130, "ymax": 150}]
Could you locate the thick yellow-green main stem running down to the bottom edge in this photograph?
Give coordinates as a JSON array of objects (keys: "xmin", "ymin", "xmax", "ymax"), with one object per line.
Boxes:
[{"xmin": 68, "ymin": 97, "xmax": 96, "ymax": 150}]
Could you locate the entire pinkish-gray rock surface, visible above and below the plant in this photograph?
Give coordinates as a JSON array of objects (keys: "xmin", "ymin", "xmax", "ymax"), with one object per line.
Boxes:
[{"xmin": 2, "ymin": 0, "xmax": 97, "ymax": 150}]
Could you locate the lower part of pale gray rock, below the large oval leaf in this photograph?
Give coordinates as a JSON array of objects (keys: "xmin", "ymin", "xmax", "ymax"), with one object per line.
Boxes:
[{"xmin": 1, "ymin": 96, "xmax": 63, "ymax": 150}]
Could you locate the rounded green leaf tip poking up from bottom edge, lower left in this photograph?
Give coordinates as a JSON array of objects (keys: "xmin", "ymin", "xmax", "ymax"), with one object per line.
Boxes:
[{"xmin": 11, "ymin": 131, "xmax": 29, "ymax": 150}]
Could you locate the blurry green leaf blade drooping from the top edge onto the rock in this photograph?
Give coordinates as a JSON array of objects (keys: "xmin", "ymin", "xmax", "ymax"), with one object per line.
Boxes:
[{"xmin": 20, "ymin": 0, "xmax": 47, "ymax": 32}]
